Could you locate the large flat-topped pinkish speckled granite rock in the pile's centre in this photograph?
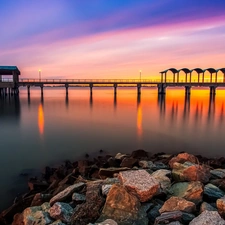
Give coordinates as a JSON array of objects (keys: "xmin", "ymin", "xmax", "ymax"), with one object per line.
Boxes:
[{"xmin": 118, "ymin": 170, "xmax": 160, "ymax": 202}]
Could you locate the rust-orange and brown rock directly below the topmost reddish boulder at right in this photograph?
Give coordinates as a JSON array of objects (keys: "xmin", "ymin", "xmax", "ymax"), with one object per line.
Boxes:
[{"xmin": 172, "ymin": 162, "xmax": 210, "ymax": 183}]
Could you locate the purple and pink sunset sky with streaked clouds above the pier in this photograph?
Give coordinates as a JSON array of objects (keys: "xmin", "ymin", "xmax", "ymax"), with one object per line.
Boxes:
[{"xmin": 0, "ymin": 0, "xmax": 225, "ymax": 79}]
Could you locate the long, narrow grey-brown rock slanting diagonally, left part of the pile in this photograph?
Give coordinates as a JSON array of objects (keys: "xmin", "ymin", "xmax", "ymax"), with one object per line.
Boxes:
[{"xmin": 50, "ymin": 182, "xmax": 85, "ymax": 206}]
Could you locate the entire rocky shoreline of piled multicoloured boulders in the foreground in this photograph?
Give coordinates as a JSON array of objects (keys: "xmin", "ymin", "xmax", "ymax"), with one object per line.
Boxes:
[{"xmin": 0, "ymin": 150, "xmax": 225, "ymax": 225}]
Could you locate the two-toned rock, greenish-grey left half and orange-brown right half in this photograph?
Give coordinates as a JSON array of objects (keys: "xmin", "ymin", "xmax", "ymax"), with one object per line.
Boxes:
[{"xmin": 169, "ymin": 181, "xmax": 204, "ymax": 204}]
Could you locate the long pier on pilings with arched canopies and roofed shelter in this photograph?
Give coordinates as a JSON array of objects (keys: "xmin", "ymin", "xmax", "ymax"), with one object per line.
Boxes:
[{"xmin": 0, "ymin": 66, "xmax": 225, "ymax": 96}]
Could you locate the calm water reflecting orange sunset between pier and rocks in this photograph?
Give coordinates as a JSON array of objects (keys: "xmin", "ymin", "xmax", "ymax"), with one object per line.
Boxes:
[{"xmin": 0, "ymin": 88, "xmax": 225, "ymax": 211}]
